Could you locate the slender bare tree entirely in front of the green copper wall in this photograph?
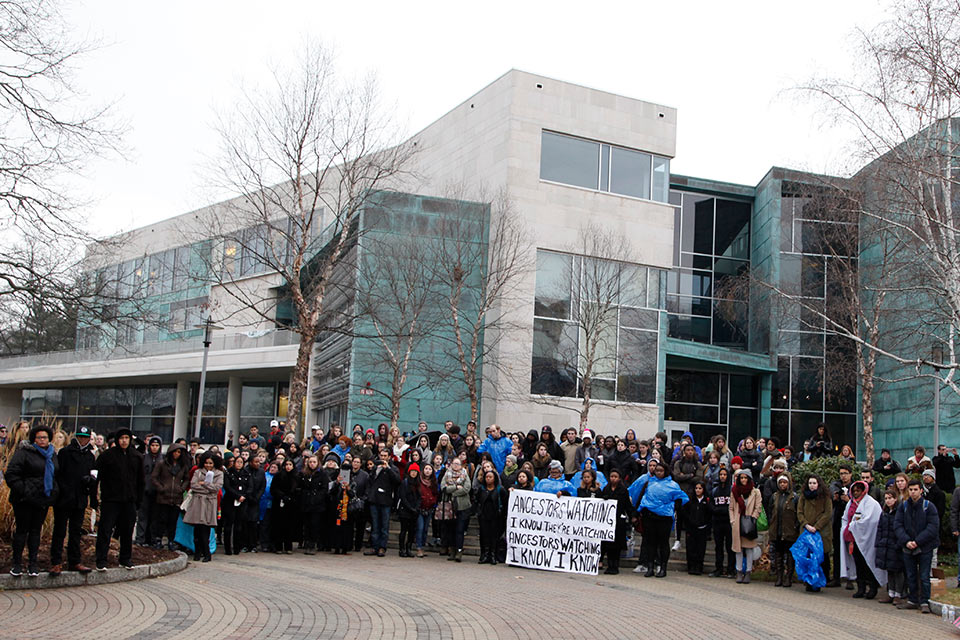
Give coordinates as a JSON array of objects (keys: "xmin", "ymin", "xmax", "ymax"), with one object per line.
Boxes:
[{"xmin": 353, "ymin": 230, "xmax": 442, "ymax": 428}]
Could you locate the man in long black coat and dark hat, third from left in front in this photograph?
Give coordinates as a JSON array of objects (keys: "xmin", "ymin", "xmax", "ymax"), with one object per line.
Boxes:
[{"xmin": 97, "ymin": 429, "xmax": 143, "ymax": 571}]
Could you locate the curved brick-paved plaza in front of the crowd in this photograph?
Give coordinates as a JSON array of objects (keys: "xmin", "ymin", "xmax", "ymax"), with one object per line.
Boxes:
[{"xmin": 0, "ymin": 552, "xmax": 952, "ymax": 640}]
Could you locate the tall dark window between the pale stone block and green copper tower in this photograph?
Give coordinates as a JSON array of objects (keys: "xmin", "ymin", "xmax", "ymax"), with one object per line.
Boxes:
[{"xmin": 667, "ymin": 191, "xmax": 751, "ymax": 349}]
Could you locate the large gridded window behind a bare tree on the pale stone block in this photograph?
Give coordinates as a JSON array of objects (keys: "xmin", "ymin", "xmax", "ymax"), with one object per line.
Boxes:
[{"xmin": 530, "ymin": 250, "xmax": 665, "ymax": 404}]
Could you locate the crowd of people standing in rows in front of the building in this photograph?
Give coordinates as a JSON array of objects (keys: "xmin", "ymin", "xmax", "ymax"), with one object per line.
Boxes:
[{"xmin": 0, "ymin": 421, "xmax": 960, "ymax": 612}]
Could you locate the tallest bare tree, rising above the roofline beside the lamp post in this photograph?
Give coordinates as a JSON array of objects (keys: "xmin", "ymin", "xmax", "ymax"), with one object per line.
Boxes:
[{"xmin": 199, "ymin": 46, "xmax": 413, "ymax": 431}]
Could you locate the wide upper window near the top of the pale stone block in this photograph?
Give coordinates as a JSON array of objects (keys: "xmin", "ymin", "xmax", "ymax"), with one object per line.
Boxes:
[{"xmin": 540, "ymin": 131, "xmax": 670, "ymax": 202}]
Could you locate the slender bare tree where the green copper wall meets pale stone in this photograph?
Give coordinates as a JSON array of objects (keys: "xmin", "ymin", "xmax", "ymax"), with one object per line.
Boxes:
[{"xmin": 433, "ymin": 192, "xmax": 534, "ymax": 422}]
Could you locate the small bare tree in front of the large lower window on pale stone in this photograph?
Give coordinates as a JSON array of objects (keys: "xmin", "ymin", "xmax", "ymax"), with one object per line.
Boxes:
[{"xmin": 533, "ymin": 228, "xmax": 646, "ymax": 429}]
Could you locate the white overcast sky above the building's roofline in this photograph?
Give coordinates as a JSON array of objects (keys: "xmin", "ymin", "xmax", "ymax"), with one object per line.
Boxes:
[{"xmin": 68, "ymin": 0, "xmax": 884, "ymax": 238}]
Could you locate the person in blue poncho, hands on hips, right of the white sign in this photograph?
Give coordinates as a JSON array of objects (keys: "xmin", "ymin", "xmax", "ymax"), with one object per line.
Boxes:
[{"xmin": 640, "ymin": 460, "xmax": 690, "ymax": 578}]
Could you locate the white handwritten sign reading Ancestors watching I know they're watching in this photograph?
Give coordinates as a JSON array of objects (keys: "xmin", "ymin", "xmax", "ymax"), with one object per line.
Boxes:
[{"xmin": 507, "ymin": 489, "xmax": 617, "ymax": 575}]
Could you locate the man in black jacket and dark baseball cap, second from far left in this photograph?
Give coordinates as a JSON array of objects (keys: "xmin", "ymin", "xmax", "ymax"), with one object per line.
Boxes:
[{"xmin": 50, "ymin": 426, "xmax": 97, "ymax": 578}]
